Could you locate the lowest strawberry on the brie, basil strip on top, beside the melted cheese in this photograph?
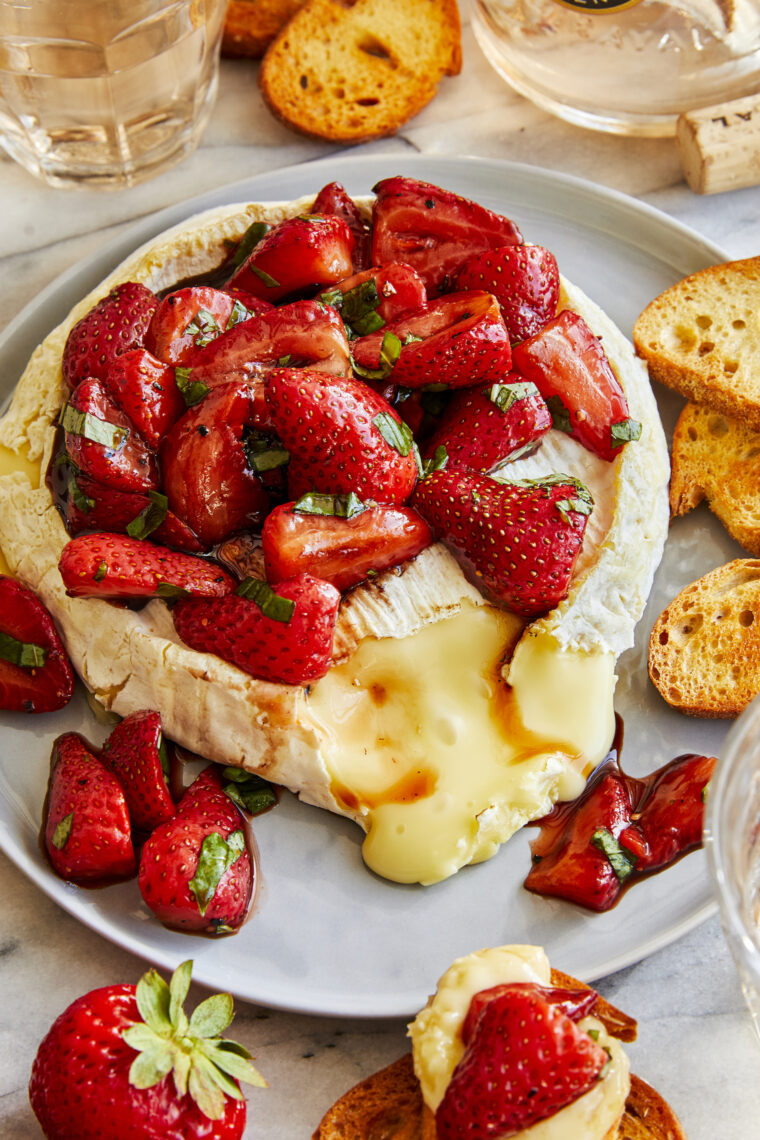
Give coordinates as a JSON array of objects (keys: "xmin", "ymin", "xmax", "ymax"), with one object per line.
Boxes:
[{"xmin": 172, "ymin": 573, "xmax": 341, "ymax": 685}]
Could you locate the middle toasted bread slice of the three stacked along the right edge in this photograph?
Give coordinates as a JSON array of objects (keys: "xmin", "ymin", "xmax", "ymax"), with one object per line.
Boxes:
[{"xmin": 670, "ymin": 404, "xmax": 760, "ymax": 557}]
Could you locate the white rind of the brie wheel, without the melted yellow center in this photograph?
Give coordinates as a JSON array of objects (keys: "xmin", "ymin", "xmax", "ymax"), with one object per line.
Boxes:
[{"xmin": 0, "ymin": 198, "xmax": 669, "ymax": 881}]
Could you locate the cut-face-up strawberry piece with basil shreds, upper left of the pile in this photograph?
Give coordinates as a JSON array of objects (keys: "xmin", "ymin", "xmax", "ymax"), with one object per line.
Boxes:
[{"xmin": 145, "ymin": 285, "xmax": 248, "ymax": 365}]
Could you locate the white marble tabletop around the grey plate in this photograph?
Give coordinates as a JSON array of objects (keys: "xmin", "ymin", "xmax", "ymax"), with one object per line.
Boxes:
[{"xmin": 0, "ymin": 2, "xmax": 760, "ymax": 1140}]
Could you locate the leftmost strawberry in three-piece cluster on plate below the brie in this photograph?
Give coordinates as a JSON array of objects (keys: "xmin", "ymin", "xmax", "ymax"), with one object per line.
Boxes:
[{"xmin": 43, "ymin": 732, "xmax": 136, "ymax": 882}]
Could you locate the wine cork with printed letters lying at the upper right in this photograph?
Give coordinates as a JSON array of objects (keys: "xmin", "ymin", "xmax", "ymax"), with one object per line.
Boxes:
[{"xmin": 676, "ymin": 95, "xmax": 760, "ymax": 194}]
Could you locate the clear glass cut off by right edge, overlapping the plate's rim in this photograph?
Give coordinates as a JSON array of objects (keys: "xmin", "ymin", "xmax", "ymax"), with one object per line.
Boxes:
[{"xmin": 704, "ymin": 697, "xmax": 760, "ymax": 1037}]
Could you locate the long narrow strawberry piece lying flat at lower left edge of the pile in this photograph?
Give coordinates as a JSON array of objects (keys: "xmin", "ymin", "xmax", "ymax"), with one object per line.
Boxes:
[{"xmin": 58, "ymin": 531, "xmax": 235, "ymax": 597}]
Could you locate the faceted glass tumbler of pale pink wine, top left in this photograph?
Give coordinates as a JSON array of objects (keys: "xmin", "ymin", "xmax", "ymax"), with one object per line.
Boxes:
[{"xmin": 0, "ymin": 0, "xmax": 227, "ymax": 188}]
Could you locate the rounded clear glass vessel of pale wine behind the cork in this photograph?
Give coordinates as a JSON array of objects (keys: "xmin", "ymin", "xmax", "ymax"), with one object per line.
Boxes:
[{"xmin": 473, "ymin": 0, "xmax": 760, "ymax": 136}]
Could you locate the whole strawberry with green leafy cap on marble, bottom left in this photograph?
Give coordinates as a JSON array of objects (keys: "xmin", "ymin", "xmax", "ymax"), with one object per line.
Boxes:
[{"xmin": 28, "ymin": 961, "xmax": 265, "ymax": 1140}]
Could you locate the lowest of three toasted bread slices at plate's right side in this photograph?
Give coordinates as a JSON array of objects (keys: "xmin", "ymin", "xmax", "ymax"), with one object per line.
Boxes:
[{"xmin": 649, "ymin": 559, "xmax": 760, "ymax": 717}]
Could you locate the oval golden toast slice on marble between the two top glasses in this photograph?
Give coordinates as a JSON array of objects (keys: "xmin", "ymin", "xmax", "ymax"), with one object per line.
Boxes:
[{"xmin": 259, "ymin": 0, "xmax": 461, "ymax": 143}]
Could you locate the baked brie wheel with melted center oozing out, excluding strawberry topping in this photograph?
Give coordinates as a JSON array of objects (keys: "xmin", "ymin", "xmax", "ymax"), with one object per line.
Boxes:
[{"xmin": 0, "ymin": 186, "xmax": 669, "ymax": 884}]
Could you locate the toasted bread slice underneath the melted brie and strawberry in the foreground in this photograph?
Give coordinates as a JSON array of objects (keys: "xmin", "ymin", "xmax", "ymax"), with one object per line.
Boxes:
[{"xmin": 312, "ymin": 969, "xmax": 686, "ymax": 1140}]
